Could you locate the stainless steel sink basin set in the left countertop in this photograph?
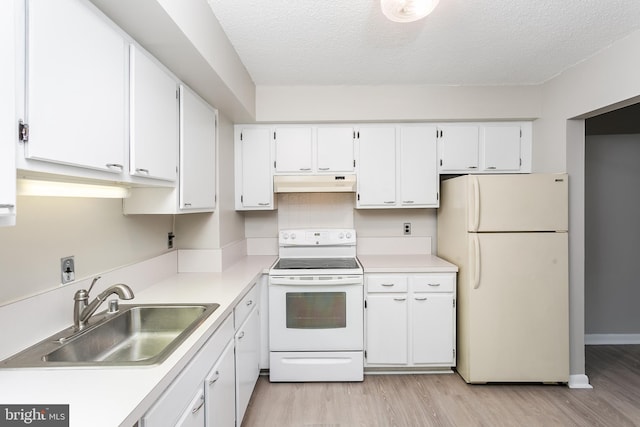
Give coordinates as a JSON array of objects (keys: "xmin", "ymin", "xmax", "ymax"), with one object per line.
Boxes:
[{"xmin": 0, "ymin": 304, "xmax": 219, "ymax": 368}]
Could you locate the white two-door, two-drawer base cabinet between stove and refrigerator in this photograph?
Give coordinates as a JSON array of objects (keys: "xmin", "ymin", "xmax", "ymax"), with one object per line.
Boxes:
[{"xmin": 365, "ymin": 273, "xmax": 456, "ymax": 368}]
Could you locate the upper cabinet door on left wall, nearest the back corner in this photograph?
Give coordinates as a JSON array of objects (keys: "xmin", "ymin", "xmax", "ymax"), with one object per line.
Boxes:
[{"xmin": 180, "ymin": 86, "xmax": 217, "ymax": 210}]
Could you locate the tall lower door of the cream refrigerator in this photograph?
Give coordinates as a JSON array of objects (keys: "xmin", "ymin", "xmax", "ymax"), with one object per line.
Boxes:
[{"xmin": 458, "ymin": 233, "xmax": 569, "ymax": 382}]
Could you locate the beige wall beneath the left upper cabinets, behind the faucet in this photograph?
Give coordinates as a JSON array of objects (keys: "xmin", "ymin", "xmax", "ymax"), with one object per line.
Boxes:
[{"xmin": 0, "ymin": 197, "xmax": 173, "ymax": 306}]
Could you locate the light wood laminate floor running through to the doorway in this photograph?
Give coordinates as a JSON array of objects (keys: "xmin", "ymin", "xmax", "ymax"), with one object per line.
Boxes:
[{"xmin": 242, "ymin": 345, "xmax": 640, "ymax": 427}]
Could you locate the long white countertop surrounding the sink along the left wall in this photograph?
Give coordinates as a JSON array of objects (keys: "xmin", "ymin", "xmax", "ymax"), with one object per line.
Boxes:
[{"xmin": 0, "ymin": 256, "xmax": 275, "ymax": 427}]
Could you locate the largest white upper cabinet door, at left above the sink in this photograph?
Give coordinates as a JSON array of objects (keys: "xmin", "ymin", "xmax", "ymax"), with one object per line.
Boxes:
[{"xmin": 25, "ymin": 0, "xmax": 127, "ymax": 174}]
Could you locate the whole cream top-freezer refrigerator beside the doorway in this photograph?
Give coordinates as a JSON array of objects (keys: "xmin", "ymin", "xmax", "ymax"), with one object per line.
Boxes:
[{"xmin": 437, "ymin": 174, "xmax": 569, "ymax": 383}]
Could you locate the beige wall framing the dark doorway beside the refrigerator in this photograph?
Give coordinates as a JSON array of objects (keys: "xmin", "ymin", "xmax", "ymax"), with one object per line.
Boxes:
[{"xmin": 533, "ymin": 31, "xmax": 640, "ymax": 374}]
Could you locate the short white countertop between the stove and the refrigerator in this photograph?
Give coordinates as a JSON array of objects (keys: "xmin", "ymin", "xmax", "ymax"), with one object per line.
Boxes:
[{"xmin": 358, "ymin": 255, "xmax": 458, "ymax": 274}]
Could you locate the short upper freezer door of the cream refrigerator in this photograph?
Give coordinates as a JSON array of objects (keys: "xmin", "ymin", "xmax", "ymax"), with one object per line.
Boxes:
[{"xmin": 467, "ymin": 174, "xmax": 569, "ymax": 232}]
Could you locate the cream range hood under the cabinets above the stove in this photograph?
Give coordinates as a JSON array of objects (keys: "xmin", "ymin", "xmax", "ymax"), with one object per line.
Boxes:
[{"xmin": 273, "ymin": 175, "xmax": 356, "ymax": 193}]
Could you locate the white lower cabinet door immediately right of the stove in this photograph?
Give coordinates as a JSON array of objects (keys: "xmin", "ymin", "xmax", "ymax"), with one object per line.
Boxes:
[{"xmin": 366, "ymin": 294, "xmax": 408, "ymax": 365}]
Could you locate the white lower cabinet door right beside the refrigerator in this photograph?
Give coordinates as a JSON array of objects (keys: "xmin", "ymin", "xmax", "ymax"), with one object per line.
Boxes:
[{"xmin": 411, "ymin": 293, "xmax": 455, "ymax": 365}]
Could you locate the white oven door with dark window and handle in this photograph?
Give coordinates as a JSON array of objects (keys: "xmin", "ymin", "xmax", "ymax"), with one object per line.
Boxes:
[{"xmin": 269, "ymin": 275, "xmax": 364, "ymax": 351}]
